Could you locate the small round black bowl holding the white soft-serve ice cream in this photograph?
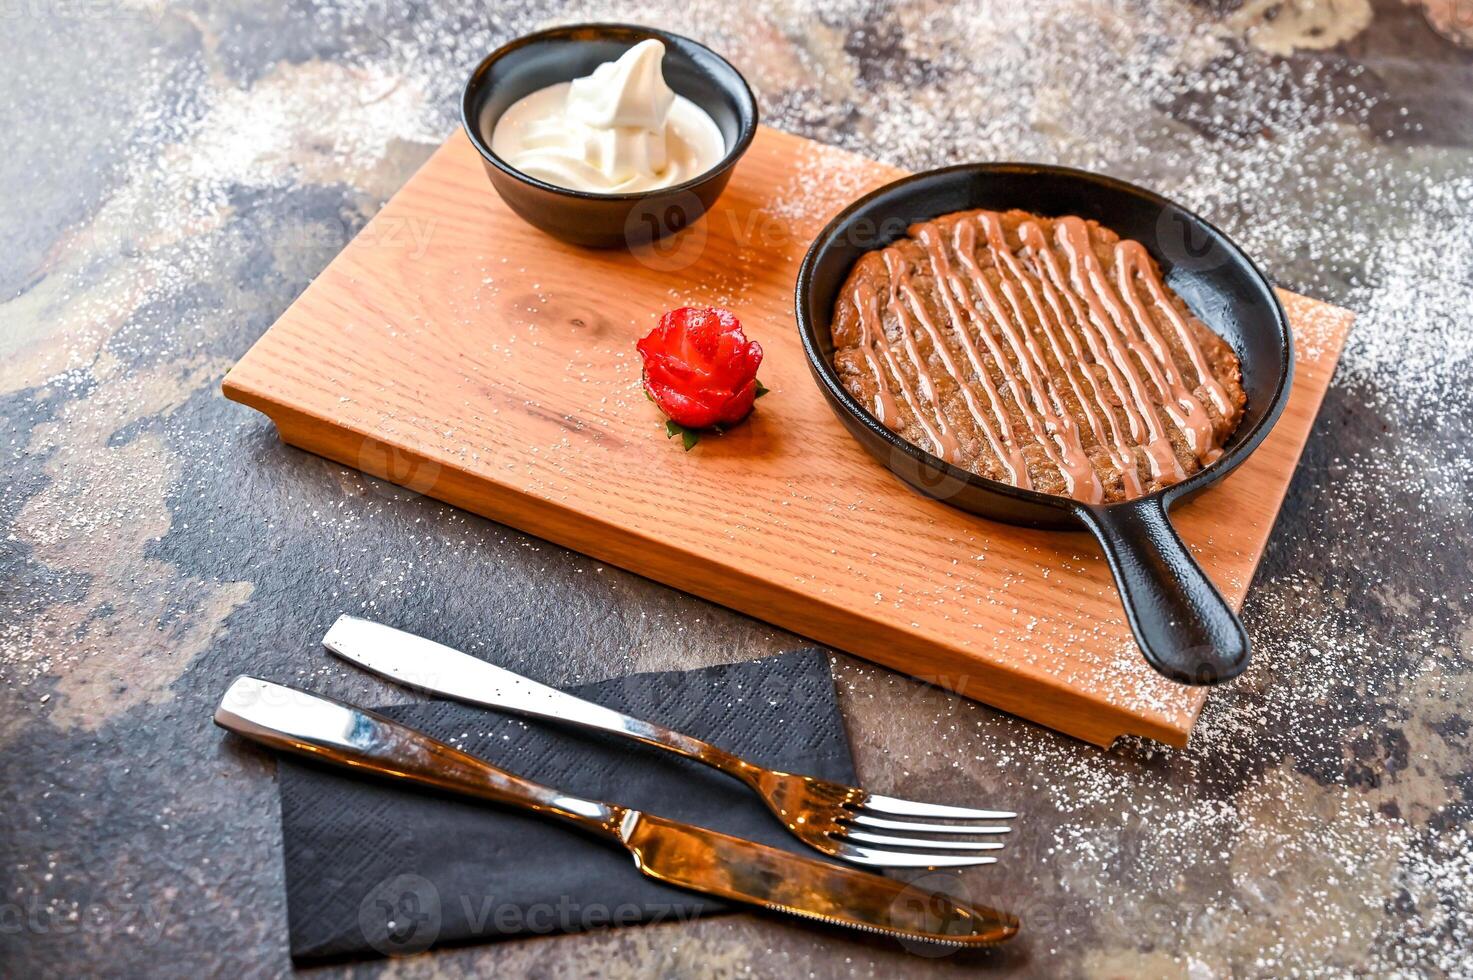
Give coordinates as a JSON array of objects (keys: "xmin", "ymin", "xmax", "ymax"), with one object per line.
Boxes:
[{"xmin": 461, "ymin": 24, "xmax": 757, "ymax": 248}]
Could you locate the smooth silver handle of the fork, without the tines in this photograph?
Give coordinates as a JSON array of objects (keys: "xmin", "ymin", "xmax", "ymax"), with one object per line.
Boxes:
[{"xmin": 323, "ymin": 616, "xmax": 764, "ymax": 788}]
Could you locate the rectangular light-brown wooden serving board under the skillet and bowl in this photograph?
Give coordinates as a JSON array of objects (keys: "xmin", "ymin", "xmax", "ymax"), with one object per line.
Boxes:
[{"xmin": 224, "ymin": 128, "xmax": 1351, "ymax": 746}]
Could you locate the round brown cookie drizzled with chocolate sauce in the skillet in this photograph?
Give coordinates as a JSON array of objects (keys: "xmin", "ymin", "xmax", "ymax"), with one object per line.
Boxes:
[{"xmin": 832, "ymin": 211, "xmax": 1245, "ymax": 504}]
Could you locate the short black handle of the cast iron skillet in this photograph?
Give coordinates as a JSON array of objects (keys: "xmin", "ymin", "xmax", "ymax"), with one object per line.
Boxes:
[{"xmin": 1078, "ymin": 495, "xmax": 1249, "ymax": 684}]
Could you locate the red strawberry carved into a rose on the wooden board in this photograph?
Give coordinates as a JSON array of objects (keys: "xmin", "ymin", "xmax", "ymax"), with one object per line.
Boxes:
[{"xmin": 639, "ymin": 307, "xmax": 767, "ymax": 449}]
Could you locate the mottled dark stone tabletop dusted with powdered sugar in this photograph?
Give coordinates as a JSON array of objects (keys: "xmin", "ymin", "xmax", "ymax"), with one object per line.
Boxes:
[{"xmin": 0, "ymin": 0, "xmax": 1473, "ymax": 977}]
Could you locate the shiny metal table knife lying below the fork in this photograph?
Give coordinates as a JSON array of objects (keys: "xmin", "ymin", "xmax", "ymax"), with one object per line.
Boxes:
[{"xmin": 215, "ymin": 676, "xmax": 1018, "ymax": 946}]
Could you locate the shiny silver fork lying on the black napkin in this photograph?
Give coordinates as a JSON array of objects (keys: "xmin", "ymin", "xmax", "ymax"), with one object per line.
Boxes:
[{"xmin": 323, "ymin": 616, "xmax": 1016, "ymax": 868}]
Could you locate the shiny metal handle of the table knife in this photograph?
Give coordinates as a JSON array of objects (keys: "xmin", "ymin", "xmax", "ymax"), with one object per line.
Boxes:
[{"xmin": 215, "ymin": 676, "xmax": 626, "ymax": 840}]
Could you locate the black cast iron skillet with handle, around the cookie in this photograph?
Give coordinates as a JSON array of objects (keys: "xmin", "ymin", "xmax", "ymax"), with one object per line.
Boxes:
[{"xmin": 797, "ymin": 164, "xmax": 1293, "ymax": 684}]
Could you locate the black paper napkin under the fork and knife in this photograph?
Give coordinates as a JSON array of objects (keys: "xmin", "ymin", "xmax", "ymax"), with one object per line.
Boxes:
[{"xmin": 280, "ymin": 648, "xmax": 856, "ymax": 961}]
